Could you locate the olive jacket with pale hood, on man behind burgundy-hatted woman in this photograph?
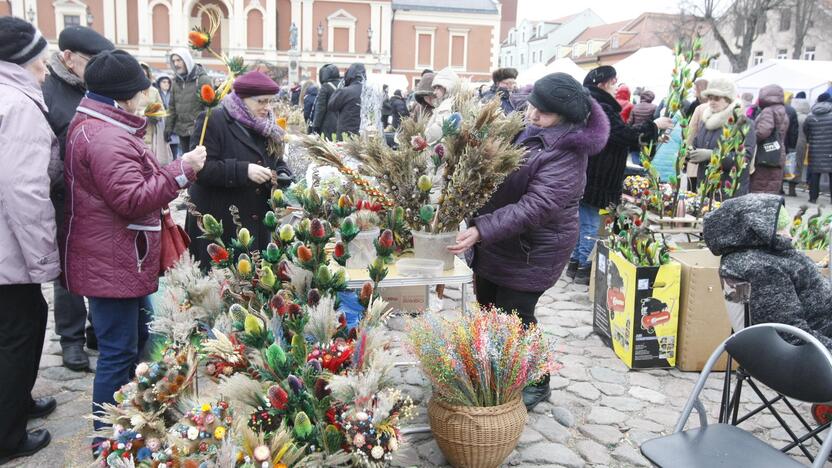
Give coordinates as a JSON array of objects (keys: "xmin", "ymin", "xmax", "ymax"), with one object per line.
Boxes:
[{"xmin": 165, "ymin": 48, "xmax": 211, "ymax": 141}]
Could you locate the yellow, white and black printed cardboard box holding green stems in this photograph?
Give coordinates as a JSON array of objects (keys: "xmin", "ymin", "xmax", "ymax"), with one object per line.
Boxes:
[{"xmin": 593, "ymin": 242, "xmax": 681, "ymax": 369}]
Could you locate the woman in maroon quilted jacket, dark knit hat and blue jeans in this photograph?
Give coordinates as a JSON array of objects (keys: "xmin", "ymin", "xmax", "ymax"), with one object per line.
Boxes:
[{"xmin": 61, "ymin": 50, "xmax": 205, "ymax": 444}]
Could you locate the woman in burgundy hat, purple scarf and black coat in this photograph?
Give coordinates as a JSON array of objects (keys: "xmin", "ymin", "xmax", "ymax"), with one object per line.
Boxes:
[{"xmin": 185, "ymin": 71, "xmax": 291, "ymax": 270}]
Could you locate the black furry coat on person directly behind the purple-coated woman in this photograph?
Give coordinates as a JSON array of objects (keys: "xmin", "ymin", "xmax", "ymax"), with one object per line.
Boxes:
[{"xmin": 583, "ymin": 86, "xmax": 658, "ymax": 208}]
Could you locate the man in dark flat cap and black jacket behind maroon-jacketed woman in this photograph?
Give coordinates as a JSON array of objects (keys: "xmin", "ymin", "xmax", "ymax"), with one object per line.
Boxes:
[{"xmin": 43, "ymin": 26, "xmax": 115, "ymax": 371}]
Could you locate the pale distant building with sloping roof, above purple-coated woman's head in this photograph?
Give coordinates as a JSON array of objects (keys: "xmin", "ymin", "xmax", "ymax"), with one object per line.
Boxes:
[{"xmin": 500, "ymin": 9, "xmax": 604, "ymax": 71}]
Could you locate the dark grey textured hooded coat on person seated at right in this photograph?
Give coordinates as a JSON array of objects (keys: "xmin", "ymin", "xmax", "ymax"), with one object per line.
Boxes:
[{"xmin": 704, "ymin": 194, "xmax": 832, "ymax": 348}]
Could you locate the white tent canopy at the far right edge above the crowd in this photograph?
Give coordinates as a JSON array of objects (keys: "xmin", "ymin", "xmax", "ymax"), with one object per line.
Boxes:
[{"xmin": 736, "ymin": 60, "xmax": 832, "ymax": 102}]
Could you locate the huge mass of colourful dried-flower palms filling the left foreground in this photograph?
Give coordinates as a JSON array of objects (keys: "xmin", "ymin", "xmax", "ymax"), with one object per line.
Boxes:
[{"xmin": 92, "ymin": 196, "xmax": 413, "ymax": 468}]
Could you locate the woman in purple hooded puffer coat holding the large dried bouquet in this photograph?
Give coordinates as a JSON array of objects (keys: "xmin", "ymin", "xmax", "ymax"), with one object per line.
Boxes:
[{"xmin": 450, "ymin": 73, "xmax": 610, "ymax": 409}]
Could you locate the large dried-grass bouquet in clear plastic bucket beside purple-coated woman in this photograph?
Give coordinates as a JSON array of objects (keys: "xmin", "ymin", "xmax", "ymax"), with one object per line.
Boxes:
[{"xmin": 304, "ymin": 90, "xmax": 523, "ymax": 233}]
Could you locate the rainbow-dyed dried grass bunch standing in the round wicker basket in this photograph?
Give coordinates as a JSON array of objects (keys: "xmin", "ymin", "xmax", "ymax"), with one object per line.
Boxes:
[{"xmin": 408, "ymin": 306, "xmax": 558, "ymax": 407}]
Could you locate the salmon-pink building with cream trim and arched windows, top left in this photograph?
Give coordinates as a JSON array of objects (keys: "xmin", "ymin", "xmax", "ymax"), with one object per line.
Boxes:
[{"xmin": 0, "ymin": 0, "xmax": 517, "ymax": 88}]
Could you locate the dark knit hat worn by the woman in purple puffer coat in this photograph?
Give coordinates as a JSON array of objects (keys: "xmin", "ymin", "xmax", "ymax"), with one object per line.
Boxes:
[{"xmin": 528, "ymin": 73, "xmax": 591, "ymax": 123}]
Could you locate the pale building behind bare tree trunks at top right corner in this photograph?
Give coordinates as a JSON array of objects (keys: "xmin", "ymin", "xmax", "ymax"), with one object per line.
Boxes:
[{"xmin": 703, "ymin": 0, "xmax": 832, "ymax": 73}]
